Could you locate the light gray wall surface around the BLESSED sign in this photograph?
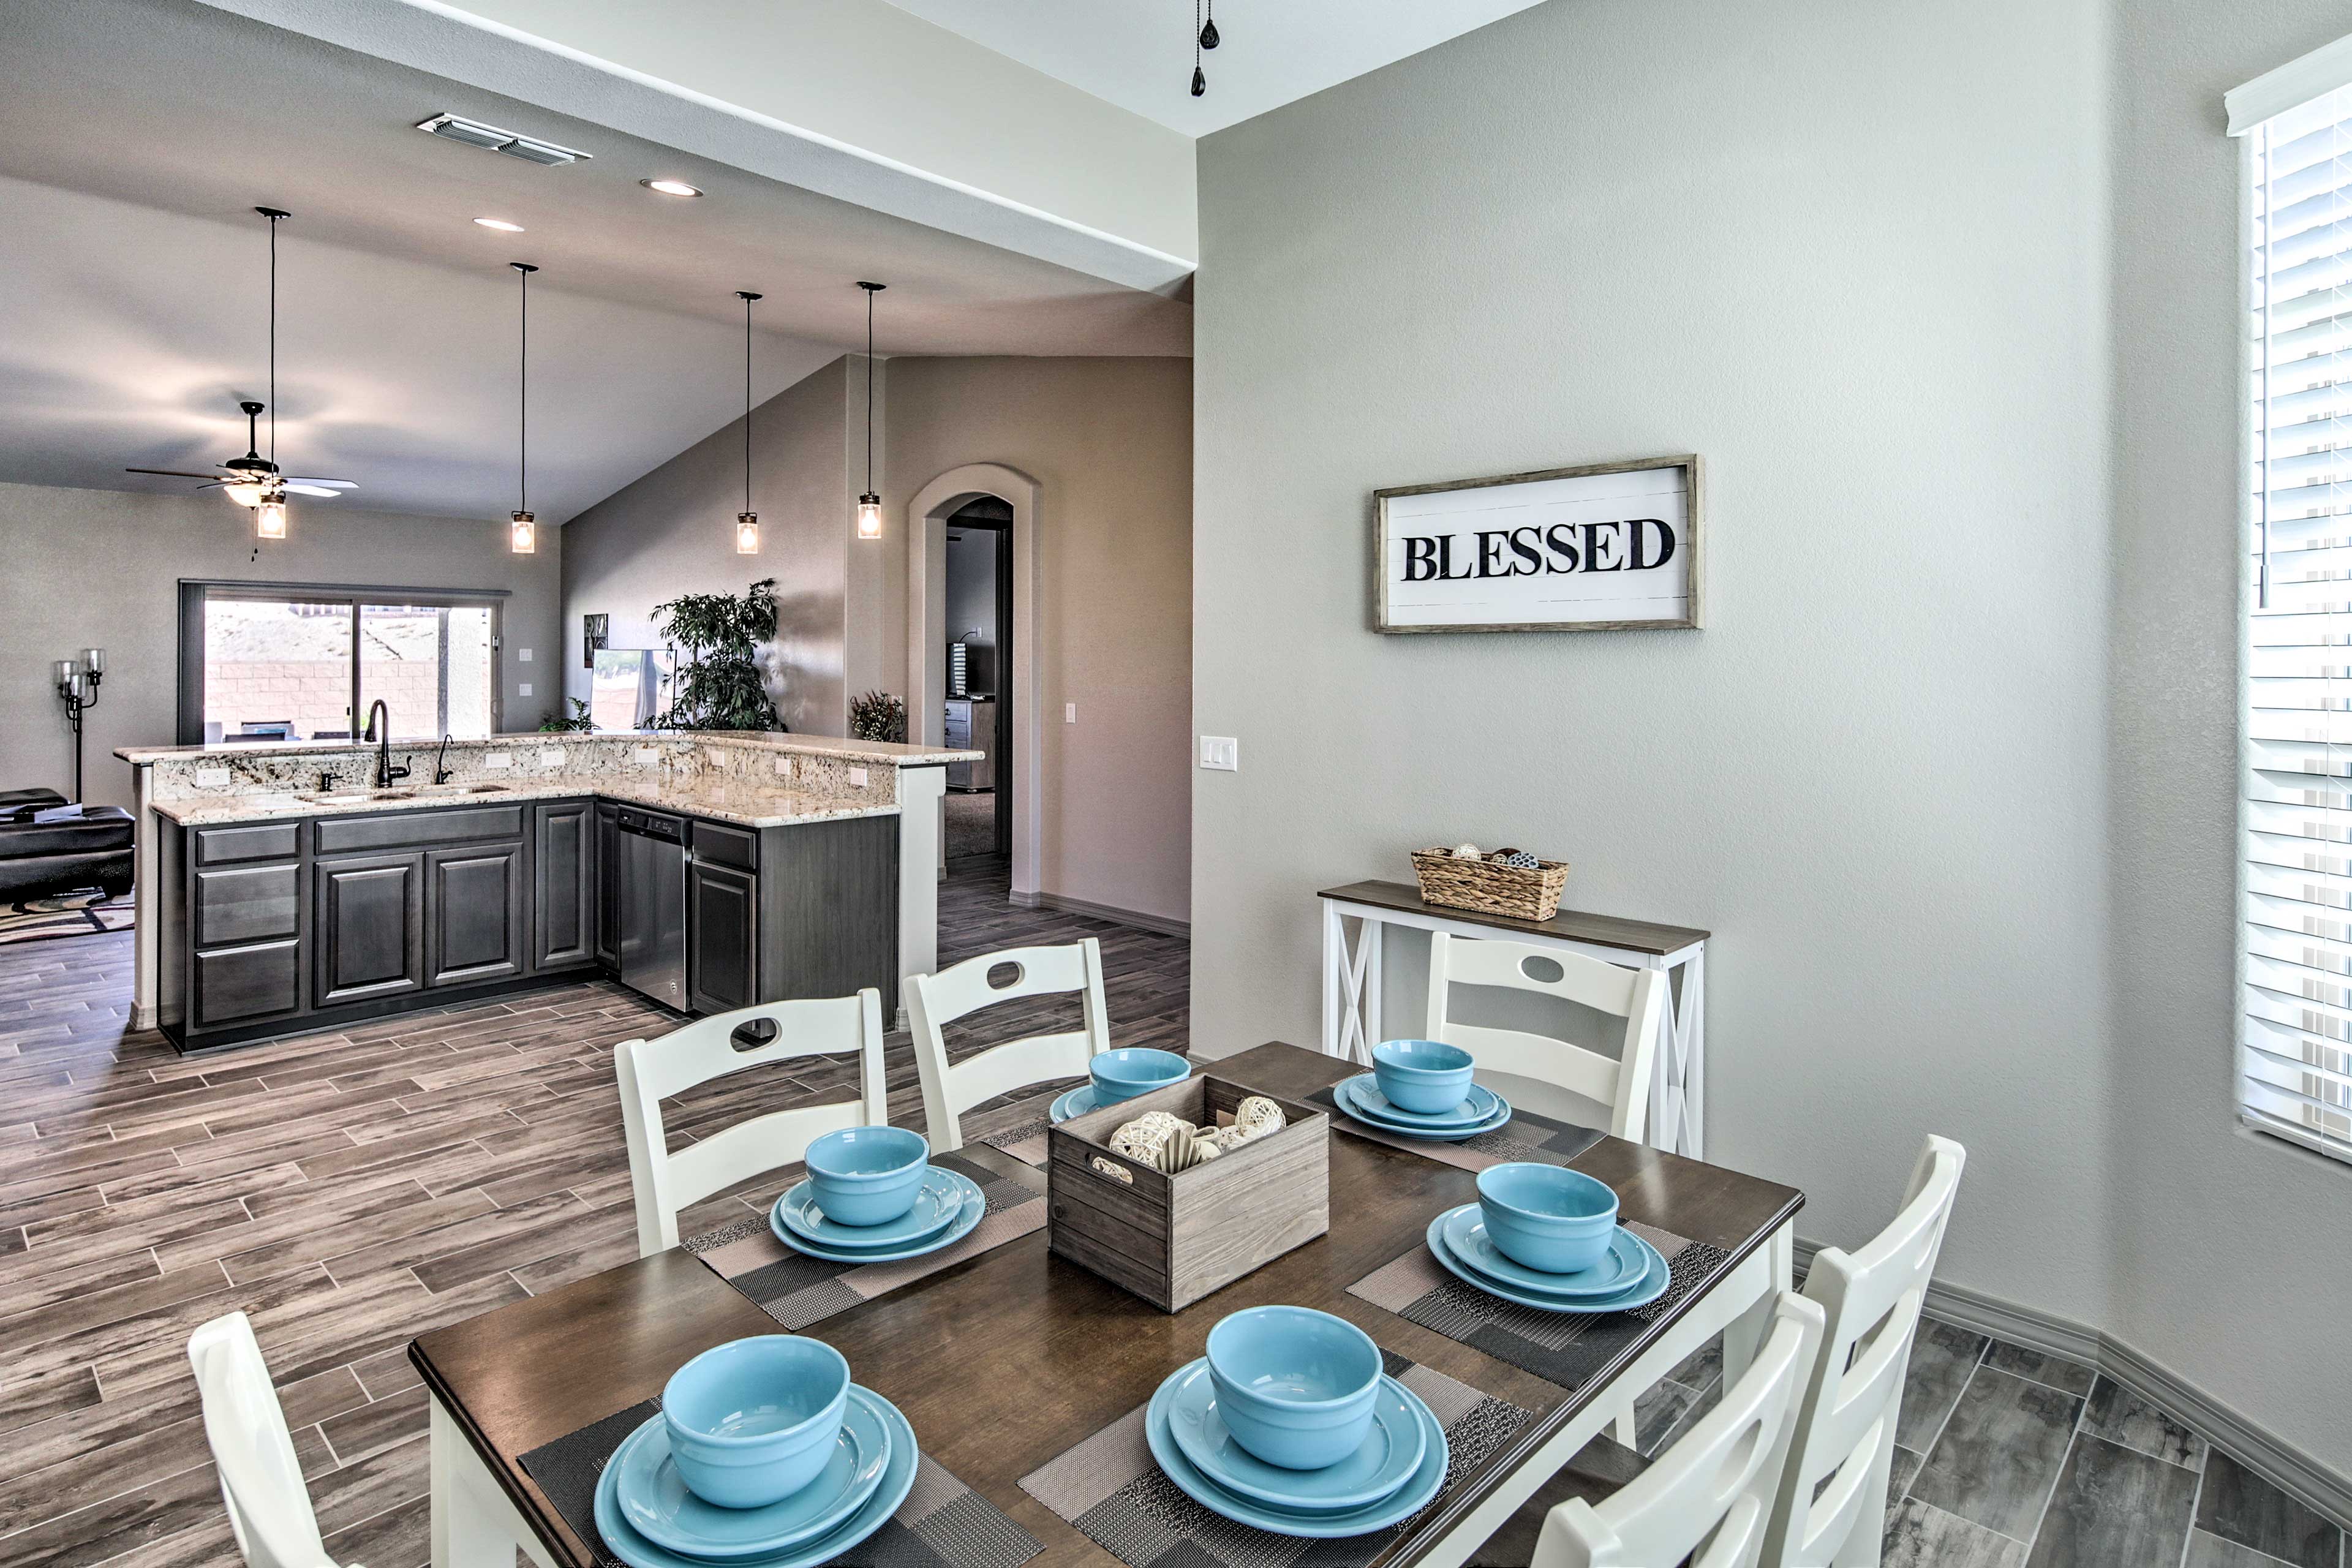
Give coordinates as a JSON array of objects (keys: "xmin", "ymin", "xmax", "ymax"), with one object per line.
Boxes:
[{"xmin": 1193, "ymin": 0, "xmax": 2117, "ymax": 1321}]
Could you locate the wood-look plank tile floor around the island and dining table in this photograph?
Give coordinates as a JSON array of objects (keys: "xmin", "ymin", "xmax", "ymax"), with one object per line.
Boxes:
[{"xmin": 0, "ymin": 865, "xmax": 2352, "ymax": 1568}]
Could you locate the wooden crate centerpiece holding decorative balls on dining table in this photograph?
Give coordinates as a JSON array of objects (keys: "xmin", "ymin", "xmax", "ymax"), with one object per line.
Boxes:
[{"xmin": 1047, "ymin": 1074, "xmax": 1331, "ymax": 1312}]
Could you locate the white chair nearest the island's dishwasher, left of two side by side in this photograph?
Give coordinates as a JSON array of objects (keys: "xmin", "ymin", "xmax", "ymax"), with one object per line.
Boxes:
[{"xmin": 611, "ymin": 985, "xmax": 889, "ymax": 1257}]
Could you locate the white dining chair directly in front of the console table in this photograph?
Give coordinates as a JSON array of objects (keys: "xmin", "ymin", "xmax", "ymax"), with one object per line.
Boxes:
[{"xmin": 1425, "ymin": 931, "xmax": 1668, "ymax": 1142}]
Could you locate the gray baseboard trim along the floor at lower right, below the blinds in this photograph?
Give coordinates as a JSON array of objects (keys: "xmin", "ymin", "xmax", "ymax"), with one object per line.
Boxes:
[{"xmin": 1797, "ymin": 1237, "xmax": 2352, "ymax": 1531}]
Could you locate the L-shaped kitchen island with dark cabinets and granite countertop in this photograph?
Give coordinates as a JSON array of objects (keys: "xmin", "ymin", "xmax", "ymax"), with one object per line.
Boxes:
[{"xmin": 118, "ymin": 731, "xmax": 971, "ymax": 1049}]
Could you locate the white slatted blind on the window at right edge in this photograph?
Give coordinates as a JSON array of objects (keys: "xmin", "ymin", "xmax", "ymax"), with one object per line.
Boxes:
[{"xmin": 2232, "ymin": 87, "xmax": 2352, "ymax": 1161}]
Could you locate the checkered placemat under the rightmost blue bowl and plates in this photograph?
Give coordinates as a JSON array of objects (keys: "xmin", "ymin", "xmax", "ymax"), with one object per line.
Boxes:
[{"xmin": 1348, "ymin": 1223, "xmax": 1731, "ymax": 1389}]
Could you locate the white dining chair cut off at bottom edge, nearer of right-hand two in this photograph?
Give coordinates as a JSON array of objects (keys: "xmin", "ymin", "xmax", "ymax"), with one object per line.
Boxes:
[{"xmin": 1529, "ymin": 1291, "xmax": 1823, "ymax": 1568}]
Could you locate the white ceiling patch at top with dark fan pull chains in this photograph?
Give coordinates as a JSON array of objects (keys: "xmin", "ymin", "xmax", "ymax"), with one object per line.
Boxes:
[{"xmin": 889, "ymin": 0, "xmax": 1538, "ymax": 137}]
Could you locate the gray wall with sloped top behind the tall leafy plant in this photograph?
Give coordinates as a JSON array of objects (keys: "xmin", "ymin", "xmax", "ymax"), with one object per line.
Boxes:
[{"xmin": 562, "ymin": 360, "xmax": 863, "ymax": 736}]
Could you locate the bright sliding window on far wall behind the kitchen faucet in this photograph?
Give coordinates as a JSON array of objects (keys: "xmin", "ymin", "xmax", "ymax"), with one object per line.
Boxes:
[{"xmin": 179, "ymin": 583, "xmax": 499, "ymax": 745}]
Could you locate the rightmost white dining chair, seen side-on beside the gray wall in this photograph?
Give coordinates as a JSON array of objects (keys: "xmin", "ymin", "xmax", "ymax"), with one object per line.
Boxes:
[{"xmin": 1764, "ymin": 1133, "xmax": 1969, "ymax": 1568}]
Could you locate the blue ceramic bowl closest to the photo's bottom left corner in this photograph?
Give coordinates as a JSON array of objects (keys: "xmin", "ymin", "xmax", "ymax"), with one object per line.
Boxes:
[{"xmin": 661, "ymin": 1333, "xmax": 849, "ymax": 1509}]
